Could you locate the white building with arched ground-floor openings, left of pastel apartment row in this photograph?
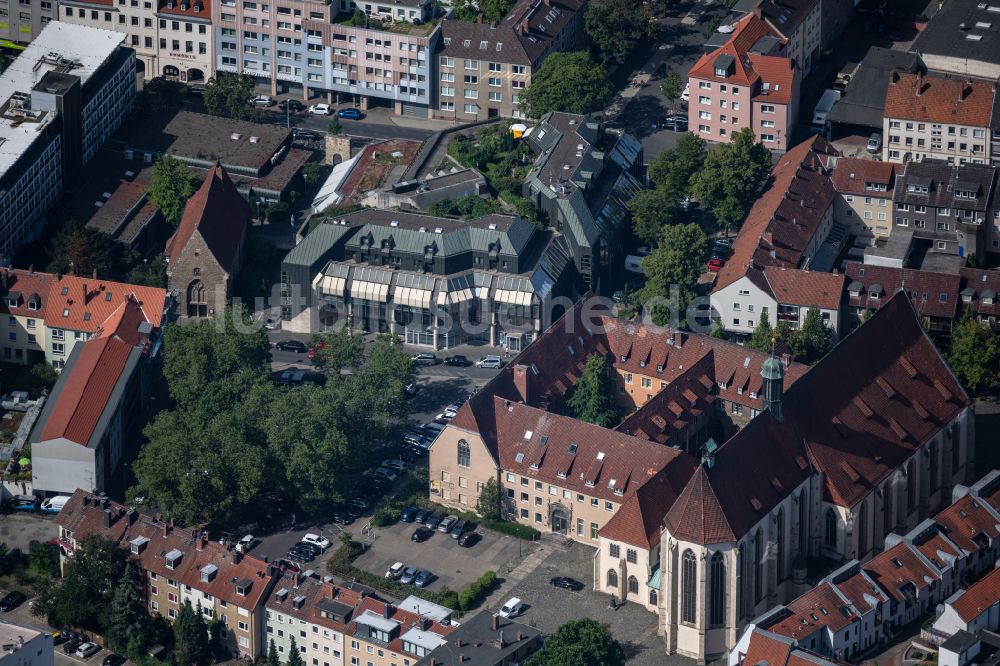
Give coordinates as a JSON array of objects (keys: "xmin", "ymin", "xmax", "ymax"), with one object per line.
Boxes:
[{"xmin": 59, "ymin": 0, "xmax": 215, "ymax": 83}]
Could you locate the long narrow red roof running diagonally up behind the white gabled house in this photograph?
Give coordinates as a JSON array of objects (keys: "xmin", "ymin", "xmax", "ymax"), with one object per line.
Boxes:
[{"xmin": 713, "ymin": 134, "xmax": 839, "ymax": 291}]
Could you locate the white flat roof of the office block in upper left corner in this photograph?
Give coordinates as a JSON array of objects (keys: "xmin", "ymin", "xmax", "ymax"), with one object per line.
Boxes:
[{"xmin": 0, "ymin": 21, "xmax": 127, "ymax": 178}]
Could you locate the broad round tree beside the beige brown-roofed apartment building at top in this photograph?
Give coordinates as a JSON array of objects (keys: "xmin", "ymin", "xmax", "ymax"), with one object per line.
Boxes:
[{"xmin": 521, "ymin": 51, "xmax": 614, "ymax": 118}]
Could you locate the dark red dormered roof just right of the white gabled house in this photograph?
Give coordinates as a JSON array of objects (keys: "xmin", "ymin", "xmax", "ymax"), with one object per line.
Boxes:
[{"xmin": 844, "ymin": 261, "xmax": 960, "ymax": 319}]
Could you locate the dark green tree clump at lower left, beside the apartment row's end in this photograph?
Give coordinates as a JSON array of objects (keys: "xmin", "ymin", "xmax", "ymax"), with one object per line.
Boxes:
[{"xmin": 35, "ymin": 535, "xmax": 125, "ymax": 634}]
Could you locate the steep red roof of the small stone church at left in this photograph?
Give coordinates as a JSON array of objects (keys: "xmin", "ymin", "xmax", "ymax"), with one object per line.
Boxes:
[{"xmin": 163, "ymin": 164, "xmax": 250, "ymax": 271}]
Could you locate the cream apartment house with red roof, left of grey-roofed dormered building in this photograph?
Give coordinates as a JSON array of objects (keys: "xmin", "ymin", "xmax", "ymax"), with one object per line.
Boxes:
[{"xmin": 830, "ymin": 157, "xmax": 898, "ymax": 240}]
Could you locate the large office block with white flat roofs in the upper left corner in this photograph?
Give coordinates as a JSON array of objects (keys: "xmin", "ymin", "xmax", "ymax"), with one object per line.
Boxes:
[{"xmin": 0, "ymin": 21, "xmax": 136, "ymax": 265}]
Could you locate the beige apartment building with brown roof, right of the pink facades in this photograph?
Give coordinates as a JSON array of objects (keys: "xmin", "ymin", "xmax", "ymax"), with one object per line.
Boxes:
[{"xmin": 432, "ymin": 0, "xmax": 586, "ymax": 122}]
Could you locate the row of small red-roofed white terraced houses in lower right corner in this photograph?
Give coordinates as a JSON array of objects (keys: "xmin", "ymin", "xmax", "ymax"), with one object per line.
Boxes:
[{"xmin": 729, "ymin": 471, "xmax": 1000, "ymax": 664}]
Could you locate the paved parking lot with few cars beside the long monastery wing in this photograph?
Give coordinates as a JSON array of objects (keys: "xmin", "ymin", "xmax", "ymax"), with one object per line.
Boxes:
[{"xmin": 354, "ymin": 512, "xmax": 535, "ymax": 591}]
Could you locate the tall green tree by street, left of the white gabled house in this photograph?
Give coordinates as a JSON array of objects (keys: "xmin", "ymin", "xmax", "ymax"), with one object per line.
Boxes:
[{"xmin": 637, "ymin": 222, "xmax": 708, "ymax": 325}]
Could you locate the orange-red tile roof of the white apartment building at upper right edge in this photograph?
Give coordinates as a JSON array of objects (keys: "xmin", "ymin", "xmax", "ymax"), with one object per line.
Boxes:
[{"xmin": 883, "ymin": 72, "xmax": 996, "ymax": 127}]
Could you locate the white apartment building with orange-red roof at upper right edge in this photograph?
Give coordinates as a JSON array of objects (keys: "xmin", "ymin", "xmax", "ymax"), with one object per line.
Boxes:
[{"xmin": 882, "ymin": 72, "xmax": 1000, "ymax": 164}]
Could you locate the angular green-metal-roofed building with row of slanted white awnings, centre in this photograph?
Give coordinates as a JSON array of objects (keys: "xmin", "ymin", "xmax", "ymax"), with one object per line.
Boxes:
[{"xmin": 281, "ymin": 209, "xmax": 577, "ymax": 351}]
